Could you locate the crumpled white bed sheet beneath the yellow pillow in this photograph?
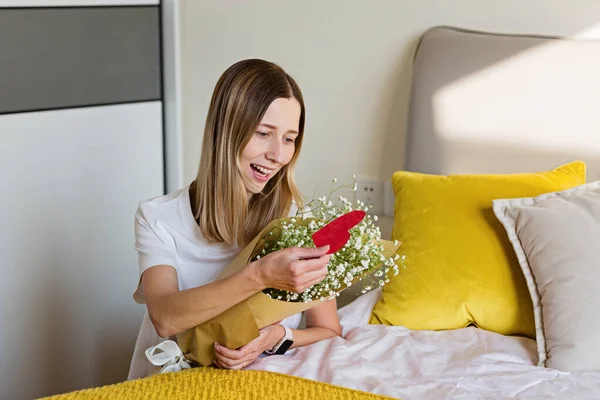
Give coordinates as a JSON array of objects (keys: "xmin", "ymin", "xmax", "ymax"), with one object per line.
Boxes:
[{"xmin": 247, "ymin": 291, "xmax": 600, "ymax": 400}]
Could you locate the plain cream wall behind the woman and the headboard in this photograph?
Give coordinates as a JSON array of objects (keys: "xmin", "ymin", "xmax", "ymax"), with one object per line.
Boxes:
[{"xmin": 181, "ymin": 0, "xmax": 600, "ymax": 239}]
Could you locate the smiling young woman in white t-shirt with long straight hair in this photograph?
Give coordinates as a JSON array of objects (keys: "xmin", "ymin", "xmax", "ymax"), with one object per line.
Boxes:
[{"xmin": 129, "ymin": 60, "xmax": 341, "ymax": 379}]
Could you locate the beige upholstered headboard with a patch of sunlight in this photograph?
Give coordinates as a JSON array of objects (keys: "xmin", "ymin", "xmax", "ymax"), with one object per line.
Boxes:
[{"xmin": 405, "ymin": 27, "xmax": 600, "ymax": 181}]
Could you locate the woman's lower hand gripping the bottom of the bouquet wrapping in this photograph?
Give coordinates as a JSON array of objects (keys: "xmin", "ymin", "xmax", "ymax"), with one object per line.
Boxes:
[{"xmin": 215, "ymin": 324, "xmax": 285, "ymax": 369}]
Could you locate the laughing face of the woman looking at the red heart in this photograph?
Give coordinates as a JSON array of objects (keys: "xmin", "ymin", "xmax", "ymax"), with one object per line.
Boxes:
[{"xmin": 240, "ymin": 97, "xmax": 301, "ymax": 194}]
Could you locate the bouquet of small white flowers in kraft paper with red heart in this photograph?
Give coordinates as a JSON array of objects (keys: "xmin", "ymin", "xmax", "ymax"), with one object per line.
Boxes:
[{"xmin": 177, "ymin": 179, "xmax": 403, "ymax": 366}]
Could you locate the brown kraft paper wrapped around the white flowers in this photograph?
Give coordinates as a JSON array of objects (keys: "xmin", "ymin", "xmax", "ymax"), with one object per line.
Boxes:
[{"xmin": 177, "ymin": 218, "xmax": 400, "ymax": 366}]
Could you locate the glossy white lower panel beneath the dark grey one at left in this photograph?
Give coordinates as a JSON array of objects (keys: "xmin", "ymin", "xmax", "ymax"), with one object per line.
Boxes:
[{"xmin": 0, "ymin": 101, "xmax": 163, "ymax": 400}]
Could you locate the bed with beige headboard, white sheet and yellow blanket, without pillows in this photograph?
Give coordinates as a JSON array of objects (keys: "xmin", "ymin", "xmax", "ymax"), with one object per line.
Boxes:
[{"xmin": 41, "ymin": 27, "xmax": 600, "ymax": 400}]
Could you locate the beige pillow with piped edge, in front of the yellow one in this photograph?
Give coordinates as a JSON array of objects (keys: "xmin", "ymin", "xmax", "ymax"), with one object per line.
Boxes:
[{"xmin": 493, "ymin": 181, "xmax": 600, "ymax": 372}]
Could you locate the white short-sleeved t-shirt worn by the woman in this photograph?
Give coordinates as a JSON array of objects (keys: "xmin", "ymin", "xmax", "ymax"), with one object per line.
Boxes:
[{"xmin": 128, "ymin": 185, "xmax": 302, "ymax": 379}]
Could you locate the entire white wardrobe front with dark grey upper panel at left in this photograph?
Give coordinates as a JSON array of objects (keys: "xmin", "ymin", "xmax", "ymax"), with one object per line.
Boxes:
[{"xmin": 0, "ymin": 0, "xmax": 165, "ymax": 400}]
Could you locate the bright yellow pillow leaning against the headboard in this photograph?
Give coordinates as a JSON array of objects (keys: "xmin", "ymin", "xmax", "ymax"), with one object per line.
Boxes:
[{"xmin": 369, "ymin": 161, "xmax": 586, "ymax": 338}]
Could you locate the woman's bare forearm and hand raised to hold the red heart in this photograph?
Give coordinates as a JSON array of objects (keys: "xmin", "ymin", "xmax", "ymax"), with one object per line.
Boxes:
[{"xmin": 142, "ymin": 247, "xmax": 329, "ymax": 337}]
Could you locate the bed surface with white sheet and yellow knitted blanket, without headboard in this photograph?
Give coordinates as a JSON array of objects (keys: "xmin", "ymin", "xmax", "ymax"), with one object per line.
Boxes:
[{"xmin": 48, "ymin": 291, "xmax": 600, "ymax": 400}]
